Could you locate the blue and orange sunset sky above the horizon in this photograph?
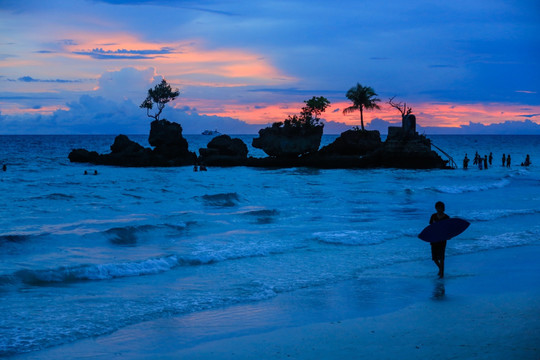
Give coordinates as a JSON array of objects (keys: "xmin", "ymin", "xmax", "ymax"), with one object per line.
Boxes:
[{"xmin": 0, "ymin": 0, "xmax": 540, "ymax": 134}]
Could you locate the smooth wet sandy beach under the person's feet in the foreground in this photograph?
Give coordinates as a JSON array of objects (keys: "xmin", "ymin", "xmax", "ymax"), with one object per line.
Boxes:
[{"xmin": 16, "ymin": 246, "xmax": 540, "ymax": 359}]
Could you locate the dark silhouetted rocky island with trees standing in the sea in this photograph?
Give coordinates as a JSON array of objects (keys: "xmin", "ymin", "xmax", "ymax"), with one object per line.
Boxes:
[{"xmin": 68, "ymin": 79, "xmax": 453, "ymax": 169}]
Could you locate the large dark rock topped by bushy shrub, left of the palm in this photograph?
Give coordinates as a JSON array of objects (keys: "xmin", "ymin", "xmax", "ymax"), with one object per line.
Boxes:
[{"xmin": 252, "ymin": 123, "xmax": 323, "ymax": 157}]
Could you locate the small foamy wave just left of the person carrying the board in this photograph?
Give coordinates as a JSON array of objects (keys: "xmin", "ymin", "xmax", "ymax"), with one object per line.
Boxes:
[{"xmin": 313, "ymin": 230, "xmax": 395, "ymax": 245}]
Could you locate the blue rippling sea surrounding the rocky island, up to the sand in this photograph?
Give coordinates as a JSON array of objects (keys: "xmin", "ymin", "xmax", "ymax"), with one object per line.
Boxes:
[{"xmin": 0, "ymin": 135, "xmax": 540, "ymax": 356}]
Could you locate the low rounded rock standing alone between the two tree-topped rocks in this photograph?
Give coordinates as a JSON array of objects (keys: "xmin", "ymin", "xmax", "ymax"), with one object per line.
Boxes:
[{"xmin": 199, "ymin": 135, "xmax": 248, "ymax": 166}]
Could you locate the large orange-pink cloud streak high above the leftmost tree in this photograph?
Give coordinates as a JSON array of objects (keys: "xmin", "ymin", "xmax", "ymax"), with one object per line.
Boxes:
[{"xmin": 64, "ymin": 33, "xmax": 295, "ymax": 86}]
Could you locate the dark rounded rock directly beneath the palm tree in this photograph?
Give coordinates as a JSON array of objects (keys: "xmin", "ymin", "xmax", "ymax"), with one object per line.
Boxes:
[{"xmin": 320, "ymin": 130, "xmax": 382, "ymax": 156}]
